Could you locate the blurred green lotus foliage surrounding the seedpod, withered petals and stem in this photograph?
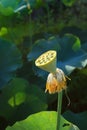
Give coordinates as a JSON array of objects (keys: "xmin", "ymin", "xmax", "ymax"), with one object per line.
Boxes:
[{"xmin": 0, "ymin": 0, "xmax": 87, "ymax": 130}]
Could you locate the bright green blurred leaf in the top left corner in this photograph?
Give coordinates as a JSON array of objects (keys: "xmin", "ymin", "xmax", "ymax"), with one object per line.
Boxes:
[{"xmin": 0, "ymin": 0, "xmax": 19, "ymax": 16}]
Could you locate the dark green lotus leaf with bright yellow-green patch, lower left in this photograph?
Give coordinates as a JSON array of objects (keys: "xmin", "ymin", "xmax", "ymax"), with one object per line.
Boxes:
[{"xmin": 0, "ymin": 78, "xmax": 47, "ymax": 123}]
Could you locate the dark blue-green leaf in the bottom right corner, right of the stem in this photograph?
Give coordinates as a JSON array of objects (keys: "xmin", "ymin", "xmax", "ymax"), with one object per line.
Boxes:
[{"xmin": 63, "ymin": 111, "xmax": 87, "ymax": 130}]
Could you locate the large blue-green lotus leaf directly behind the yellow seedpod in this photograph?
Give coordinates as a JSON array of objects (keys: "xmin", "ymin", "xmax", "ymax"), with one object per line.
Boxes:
[{"xmin": 28, "ymin": 34, "xmax": 87, "ymax": 76}]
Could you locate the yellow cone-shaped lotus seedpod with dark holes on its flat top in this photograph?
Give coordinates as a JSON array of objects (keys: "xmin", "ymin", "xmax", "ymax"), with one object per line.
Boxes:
[{"xmin": 35, "ymin": 50, "xmax": 57, "ymax": 73}]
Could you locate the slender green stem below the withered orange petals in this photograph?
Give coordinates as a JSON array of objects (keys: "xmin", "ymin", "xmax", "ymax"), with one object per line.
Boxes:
[{"xmin": 56, "ymin": 91, "xmax": 62, "ymax": 130}]
